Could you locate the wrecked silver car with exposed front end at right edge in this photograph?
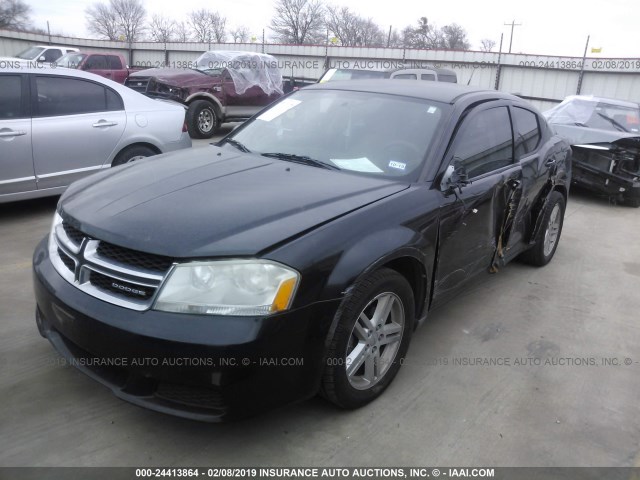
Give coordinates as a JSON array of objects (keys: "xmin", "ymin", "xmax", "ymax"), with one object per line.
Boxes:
[{"xmin": 544, "ymin": 95, "xmax": 640, "ymax": 208}]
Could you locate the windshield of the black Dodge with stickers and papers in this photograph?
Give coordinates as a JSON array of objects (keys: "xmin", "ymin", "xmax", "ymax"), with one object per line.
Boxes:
[{"xmin": 229, "ymin": 90, "xmax": 450, "ymax": 180}]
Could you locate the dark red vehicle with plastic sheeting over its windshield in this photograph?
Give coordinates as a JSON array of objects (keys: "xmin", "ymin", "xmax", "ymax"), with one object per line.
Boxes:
[{"xmin": 125, "ymin": 51, "xmax": 283, "ymax": 138}]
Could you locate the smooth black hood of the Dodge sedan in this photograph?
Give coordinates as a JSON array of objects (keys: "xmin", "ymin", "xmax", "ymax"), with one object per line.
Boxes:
[{"xmin": 60, "ymin": 147, "xmax": 408, "ymax": 258}]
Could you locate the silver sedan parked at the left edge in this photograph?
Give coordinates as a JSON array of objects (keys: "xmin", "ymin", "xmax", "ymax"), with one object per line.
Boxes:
[{"xmin": 0, "ymin": 68, "xmax": 191, "ymax": 203}]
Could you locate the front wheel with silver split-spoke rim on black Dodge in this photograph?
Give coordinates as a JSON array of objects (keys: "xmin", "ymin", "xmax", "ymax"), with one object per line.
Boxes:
[{"xmin": 321, "ymin": 268, "xmax": 415, "ymax": 409}]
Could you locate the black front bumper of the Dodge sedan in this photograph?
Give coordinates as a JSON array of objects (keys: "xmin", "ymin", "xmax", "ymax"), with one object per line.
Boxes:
[{"xmin": 33, "ymin": 239, "xmax": 339, "ymax": 422}]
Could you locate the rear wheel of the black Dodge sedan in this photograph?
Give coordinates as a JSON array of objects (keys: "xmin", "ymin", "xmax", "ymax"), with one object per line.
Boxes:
[{"xmin": 520, "ymin": 191, "xmax": 566, "ymax": 267}]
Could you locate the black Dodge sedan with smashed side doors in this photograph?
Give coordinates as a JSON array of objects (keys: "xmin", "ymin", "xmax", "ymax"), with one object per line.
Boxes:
[{"xmin": 33, "ymin": 80, "xmax": 571, "ymax": 421}]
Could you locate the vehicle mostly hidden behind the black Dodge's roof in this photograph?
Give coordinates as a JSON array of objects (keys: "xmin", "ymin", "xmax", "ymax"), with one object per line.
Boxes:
[{"xmin": 318, "ymin": 67, "xmax": 458, "ymax": 83}]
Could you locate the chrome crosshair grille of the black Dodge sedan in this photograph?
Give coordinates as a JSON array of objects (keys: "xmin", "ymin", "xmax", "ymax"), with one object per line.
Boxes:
[{"xmin": 49, "ymin": 215, "xmax": 173, "ymax": 311}]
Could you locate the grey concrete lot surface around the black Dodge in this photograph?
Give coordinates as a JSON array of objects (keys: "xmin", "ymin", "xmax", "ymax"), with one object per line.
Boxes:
[{"xmin": 0, "ymin": 141, "xmax": 640, "ymax": 467}]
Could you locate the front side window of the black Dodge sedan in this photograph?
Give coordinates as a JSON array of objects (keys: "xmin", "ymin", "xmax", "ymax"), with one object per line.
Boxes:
[{"xmin": 453, "ymin": 107, "xmax": 513, "ymax": 179}]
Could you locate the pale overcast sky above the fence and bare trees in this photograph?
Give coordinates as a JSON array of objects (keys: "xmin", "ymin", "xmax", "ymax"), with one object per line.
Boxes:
[{"xmin": 25, "ymin": 0, "xmax": 640, "ymax": 57}]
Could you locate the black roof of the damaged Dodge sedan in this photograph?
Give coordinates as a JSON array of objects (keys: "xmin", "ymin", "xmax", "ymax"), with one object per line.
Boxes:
[{"xmin": 305, "ymin": 79, "xmax": 522, "ymax": 104}]
